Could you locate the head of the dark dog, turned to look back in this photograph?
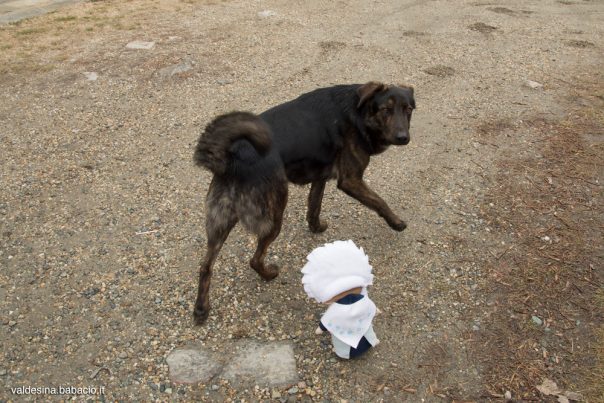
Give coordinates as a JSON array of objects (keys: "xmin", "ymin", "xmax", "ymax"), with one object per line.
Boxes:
[{"xmin": 357, "ymin": 82, "xmax": 415, "ymax": 146}]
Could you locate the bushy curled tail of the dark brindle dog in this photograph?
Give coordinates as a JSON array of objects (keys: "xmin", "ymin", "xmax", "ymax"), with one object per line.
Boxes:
[{"xmin": 193, "ymin": 112, "xmax": 272, "ymax": 175}]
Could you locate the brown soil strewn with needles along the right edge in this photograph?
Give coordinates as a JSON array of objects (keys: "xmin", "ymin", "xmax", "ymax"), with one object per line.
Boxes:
[{"xmin": 474, "ymin": 80, "xmax": 604, "ymax": 402}]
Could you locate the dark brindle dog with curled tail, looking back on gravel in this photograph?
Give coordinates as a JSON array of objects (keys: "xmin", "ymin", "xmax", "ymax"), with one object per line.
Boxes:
[{"xmin": 194, "ymin": 82, "xmax": 415, "ymax": 323}]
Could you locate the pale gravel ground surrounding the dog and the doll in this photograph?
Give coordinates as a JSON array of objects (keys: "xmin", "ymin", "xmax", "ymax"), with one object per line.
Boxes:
[{"xmin": 0, "ymin": 0, "xmax": 604, "ymax": 402}]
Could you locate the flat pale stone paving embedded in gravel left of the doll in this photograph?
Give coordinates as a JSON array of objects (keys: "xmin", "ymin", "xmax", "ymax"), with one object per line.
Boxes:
[{"xmin": 166, "ymin": 340, "xmax": 298, "ymax": 387}]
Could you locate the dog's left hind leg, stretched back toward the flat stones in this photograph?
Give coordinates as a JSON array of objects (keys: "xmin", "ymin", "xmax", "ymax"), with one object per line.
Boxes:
[{"xmin": 193, "ymin": 190, "xmax": 237, "ymax": 325}]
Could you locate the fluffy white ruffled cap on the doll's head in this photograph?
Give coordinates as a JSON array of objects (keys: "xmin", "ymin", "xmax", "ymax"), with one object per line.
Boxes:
[{"xmin": 302, "ymin": 240, "xmax": 373, "ymax": 302}]
